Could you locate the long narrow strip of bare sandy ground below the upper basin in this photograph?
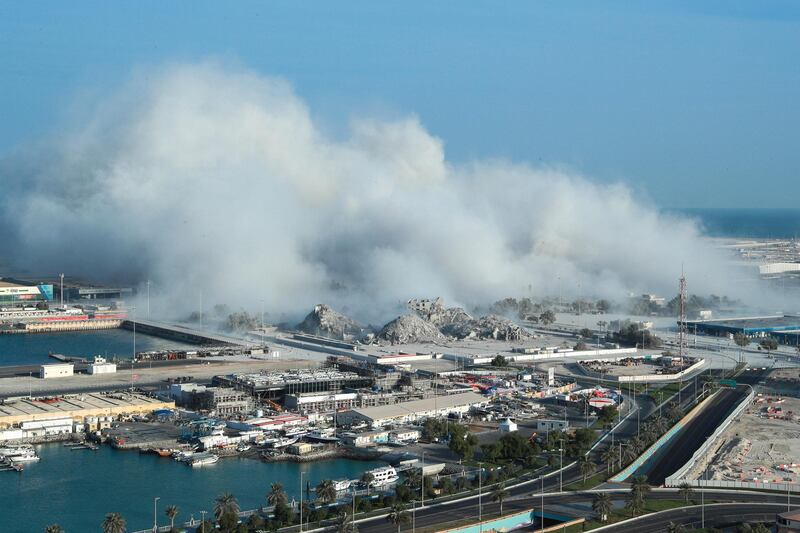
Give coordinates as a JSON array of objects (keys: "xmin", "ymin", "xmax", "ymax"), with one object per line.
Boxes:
[{"xmin": 0, "ymin": 359, "xmax": 319, "ymax": 397}]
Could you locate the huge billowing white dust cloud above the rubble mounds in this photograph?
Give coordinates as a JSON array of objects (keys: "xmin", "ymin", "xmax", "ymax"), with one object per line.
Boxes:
[{"xmin": 0, "ymin": 62, "xmax": 730, "ymax": 320}]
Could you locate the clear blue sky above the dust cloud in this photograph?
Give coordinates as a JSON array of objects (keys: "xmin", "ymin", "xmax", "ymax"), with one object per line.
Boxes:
[{"xmin": 0, "ymin": 0, "xmax": 800, "ymax": 207}]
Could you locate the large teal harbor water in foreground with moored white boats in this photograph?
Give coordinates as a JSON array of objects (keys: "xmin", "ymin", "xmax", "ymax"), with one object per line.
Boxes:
[{"xmin": 0, "ymin": 443, "xmax": 384, "ymax": 533}]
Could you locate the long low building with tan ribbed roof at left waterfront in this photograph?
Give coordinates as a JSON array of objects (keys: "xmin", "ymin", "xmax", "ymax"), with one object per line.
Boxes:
[{"xmin": 0, "ymin": 392, "xmax": 175, "ymax": 428}]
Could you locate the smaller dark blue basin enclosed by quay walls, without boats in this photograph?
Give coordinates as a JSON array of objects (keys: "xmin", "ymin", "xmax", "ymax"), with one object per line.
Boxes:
[{"xmin": 0, "ymin": 329, "xmax": 193, "ymax": 366}]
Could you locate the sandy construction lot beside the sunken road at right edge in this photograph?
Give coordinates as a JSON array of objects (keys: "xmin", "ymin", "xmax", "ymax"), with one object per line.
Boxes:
[{"xmin": 688, "ymin": 396, "xmax": 800, "ymax": 483}]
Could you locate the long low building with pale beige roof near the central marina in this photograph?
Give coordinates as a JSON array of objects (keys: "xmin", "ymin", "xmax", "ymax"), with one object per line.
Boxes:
[{"xmin": 338, "ymin": 392, "xmax": 489, "ymax": 427}]
